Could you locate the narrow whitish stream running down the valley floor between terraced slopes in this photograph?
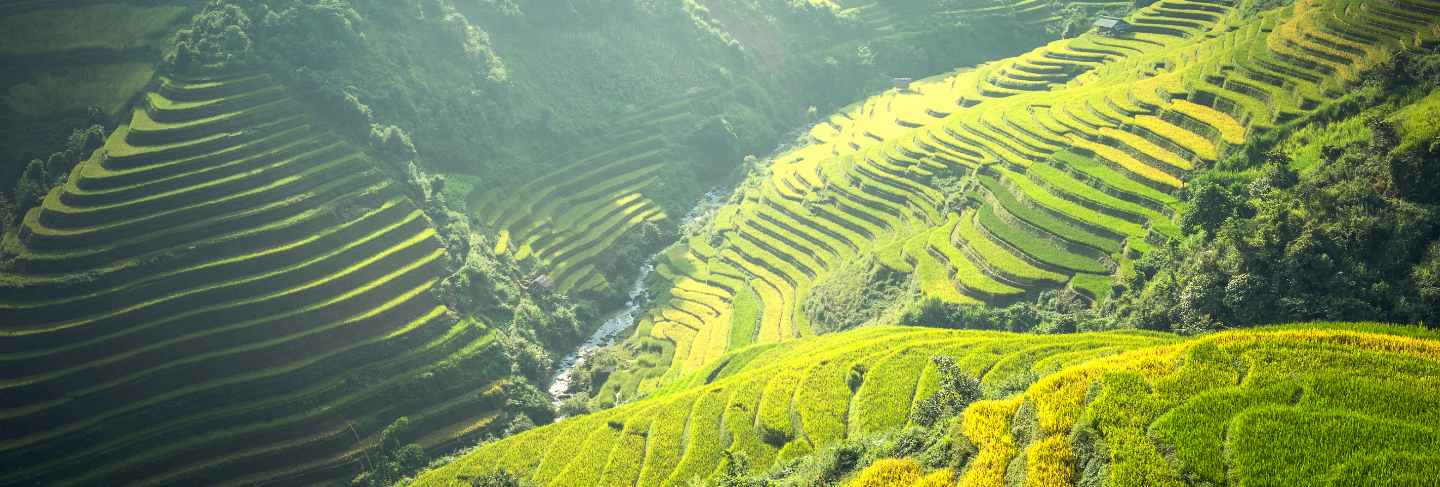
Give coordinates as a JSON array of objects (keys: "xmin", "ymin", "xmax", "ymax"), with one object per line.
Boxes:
[{"xmin": 549, "ymin": 189, "xmax": 729, "ymax": 406}]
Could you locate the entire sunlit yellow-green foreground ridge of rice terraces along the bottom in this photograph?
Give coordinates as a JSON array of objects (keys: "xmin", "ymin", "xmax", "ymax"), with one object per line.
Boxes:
[{"xmin": 418, "ymin": 323, "xmax": 1440, "ymax": 486}]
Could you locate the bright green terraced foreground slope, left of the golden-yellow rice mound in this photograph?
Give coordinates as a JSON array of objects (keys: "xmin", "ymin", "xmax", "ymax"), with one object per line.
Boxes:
[{"xmin": 419, "ymin": 327, "xmax": 1172, "ymax": 486}]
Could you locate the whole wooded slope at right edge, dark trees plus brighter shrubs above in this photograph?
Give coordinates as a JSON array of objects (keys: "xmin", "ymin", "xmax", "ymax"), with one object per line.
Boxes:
[{"xmin": 1100, "ymin": 53, "xmax": 1440, "ymax": 333}]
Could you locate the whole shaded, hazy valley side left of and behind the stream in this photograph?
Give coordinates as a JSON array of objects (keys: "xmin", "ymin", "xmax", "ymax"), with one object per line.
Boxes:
[{"xmin": 0, "ymin": 0, "xmax": 1113, "ymax": 484}]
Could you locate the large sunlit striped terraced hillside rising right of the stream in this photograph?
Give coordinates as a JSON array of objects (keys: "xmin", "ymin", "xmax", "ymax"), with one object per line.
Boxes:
[{"xmin": 599, "ymin": 0, "xmax": 1440, "ymax": 398}]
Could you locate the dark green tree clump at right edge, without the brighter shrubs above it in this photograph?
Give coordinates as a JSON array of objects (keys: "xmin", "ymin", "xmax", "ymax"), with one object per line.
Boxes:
[{"xmin": 1115, "ymin": 123, "xmax": 1440, "ymax": 328}]
